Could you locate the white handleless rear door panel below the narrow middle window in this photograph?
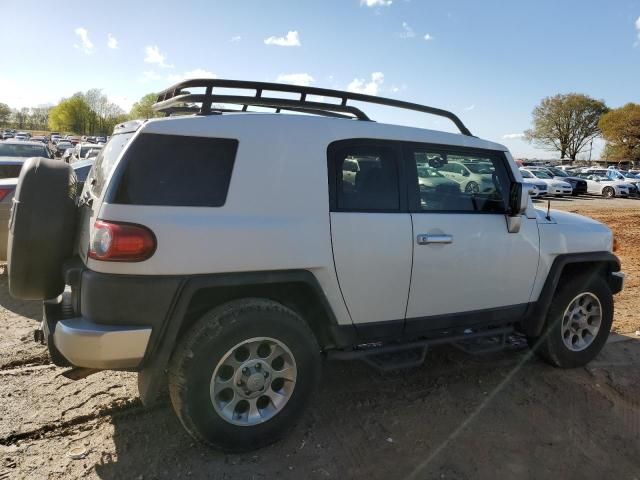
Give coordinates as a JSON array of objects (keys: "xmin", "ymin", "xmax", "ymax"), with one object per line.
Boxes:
[{"xmin": 331, "ymin": 212, "xmax": 413, "ymax": 323}]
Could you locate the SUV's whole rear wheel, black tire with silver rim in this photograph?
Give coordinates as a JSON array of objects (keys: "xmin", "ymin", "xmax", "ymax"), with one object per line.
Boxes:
[{"xmin": 168, "ymin": 298, "xmax": 320, "ymax": 452}]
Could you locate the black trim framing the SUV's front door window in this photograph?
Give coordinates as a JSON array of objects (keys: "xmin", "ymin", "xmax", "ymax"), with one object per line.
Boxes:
[{"xmin": 402, "ymin": 142, "xmax": 515, "ymax": 215}]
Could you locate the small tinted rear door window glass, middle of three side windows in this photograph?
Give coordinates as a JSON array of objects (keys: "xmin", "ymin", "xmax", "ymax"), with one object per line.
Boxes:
[{"xmin": 335, "ymin": 147, "xmax": 400, "ymax": 211}]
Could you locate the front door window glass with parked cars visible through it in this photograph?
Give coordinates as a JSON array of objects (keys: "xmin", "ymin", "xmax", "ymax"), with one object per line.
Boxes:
[{"xmin": 412, "ymin": 148, "xmax": 510, "ymax": 213}]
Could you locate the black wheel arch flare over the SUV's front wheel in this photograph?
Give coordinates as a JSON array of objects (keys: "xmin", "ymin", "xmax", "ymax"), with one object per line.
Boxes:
[{"xmin": 522, "ymin": 252, "xmax": 620, "ymax": 337}]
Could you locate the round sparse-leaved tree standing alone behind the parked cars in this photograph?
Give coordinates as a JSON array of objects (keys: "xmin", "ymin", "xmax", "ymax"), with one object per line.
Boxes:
[{"xmin": 525, "ymin": 93, "xmax": 607, "ymax": 160}]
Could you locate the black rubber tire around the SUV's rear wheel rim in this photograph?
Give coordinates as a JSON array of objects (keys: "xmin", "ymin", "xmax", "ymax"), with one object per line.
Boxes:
[{"xmin": 168, "ymin": 298, "xmax": 321, "ymax": 452}]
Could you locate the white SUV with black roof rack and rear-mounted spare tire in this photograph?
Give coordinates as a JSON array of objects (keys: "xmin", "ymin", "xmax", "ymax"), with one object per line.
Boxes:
[{"xmin": 9, "ymin": 79, "xmax": 623, "ymax": 451}]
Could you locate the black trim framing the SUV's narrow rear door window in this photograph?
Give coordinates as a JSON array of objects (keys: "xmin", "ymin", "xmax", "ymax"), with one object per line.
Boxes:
[{"xmin": 327, "ymin": 138, "xmax": 409, "ymax": 213}]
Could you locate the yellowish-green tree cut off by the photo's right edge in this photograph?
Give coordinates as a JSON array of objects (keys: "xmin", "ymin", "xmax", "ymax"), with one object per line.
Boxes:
[{"xmin": 599, "ymin": 103, "xmax": 640, "ymax": 162}]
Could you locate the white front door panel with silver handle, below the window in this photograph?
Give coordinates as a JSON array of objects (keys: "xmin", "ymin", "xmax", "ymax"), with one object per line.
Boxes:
[{"xmin": 407, "ymin": 213, "xmax": 539, "ymax": 318}]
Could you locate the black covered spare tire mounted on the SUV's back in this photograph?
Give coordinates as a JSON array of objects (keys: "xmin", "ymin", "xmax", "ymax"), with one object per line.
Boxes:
[{"xmin": 7, "ymin": 158, "xmax": 77, "ymax": 300}]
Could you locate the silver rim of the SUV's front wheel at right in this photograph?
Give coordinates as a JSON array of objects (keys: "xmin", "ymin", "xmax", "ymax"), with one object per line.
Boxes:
[{"xmin": 561, "ymin": 292, "xmax": 602, "ymax": 352}]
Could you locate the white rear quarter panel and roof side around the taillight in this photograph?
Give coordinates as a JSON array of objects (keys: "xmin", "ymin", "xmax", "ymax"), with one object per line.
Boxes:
[{"xmin": 85, "ymin": 114, "xmax": 505, "ymax": 324}]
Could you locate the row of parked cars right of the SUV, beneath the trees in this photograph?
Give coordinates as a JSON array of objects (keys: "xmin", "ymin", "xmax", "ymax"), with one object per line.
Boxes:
[{"xmin": 520, "ymin": 166, "xmax": 640, "ymax": 198}]
